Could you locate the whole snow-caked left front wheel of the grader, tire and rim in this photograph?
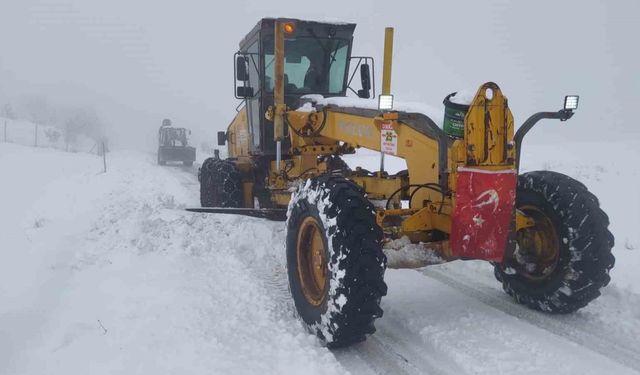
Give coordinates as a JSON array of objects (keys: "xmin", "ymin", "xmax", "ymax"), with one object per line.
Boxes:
[{"xmin": 286, "ymin": 175, "xmax": 387, "ymax": 347}]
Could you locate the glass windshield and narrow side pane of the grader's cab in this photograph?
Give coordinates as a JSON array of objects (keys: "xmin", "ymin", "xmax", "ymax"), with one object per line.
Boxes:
[{"xmin": 263, "ymin": 37, "xmax": 349, "ymax": 94}]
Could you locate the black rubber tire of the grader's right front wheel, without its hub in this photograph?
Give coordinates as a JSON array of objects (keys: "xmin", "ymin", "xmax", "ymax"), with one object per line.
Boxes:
[{"xmin": 494, "ymin": 171, "xmax": 615, "ymax": 314}]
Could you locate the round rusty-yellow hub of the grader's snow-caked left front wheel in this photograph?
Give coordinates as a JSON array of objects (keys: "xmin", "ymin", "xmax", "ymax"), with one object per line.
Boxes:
[{"xmin": 296, "ymin": 216, "xmax": 328, "ymax": 306}]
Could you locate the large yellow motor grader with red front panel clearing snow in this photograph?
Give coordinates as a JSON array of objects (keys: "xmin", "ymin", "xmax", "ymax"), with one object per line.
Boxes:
[{"xmin": 191, "ymin": 18, "xmax": 614, "ymax": 347}]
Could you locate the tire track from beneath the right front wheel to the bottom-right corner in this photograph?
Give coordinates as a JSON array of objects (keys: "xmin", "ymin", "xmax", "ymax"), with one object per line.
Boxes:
[{"xmin": 418, "ymin": 268, "xmax": 640, "ymax": 371}]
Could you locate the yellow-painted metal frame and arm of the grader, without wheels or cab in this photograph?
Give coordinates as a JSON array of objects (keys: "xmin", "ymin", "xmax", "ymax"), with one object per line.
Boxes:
[{"xmin": 222, "ymin": 22, "xmax": 534, "ymax": 257}]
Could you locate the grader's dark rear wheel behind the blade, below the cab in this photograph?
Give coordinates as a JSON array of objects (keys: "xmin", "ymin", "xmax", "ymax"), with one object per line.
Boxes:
[{"xmin": 198, "ymin": 158, "xmax": 243, "ymax": 207}]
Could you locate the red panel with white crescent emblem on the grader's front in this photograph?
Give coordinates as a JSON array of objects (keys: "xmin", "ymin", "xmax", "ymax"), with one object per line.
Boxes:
[{"xmin": 450, "ymin": 168, "xmax": 517, "ymax": 262}]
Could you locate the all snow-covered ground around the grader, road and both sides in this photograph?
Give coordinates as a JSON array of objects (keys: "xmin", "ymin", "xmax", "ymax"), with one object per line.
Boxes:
[{"xmin": 0, "ymin": 144, "xmax": 640, "ymax": 374}]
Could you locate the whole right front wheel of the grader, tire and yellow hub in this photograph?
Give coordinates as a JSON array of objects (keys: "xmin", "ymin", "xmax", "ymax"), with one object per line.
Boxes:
[{"xmin": 494, "ymin": 171, "xmax": 615, "ymax": 314}]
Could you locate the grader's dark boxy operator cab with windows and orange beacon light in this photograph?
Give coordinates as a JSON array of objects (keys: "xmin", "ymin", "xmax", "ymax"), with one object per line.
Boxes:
[{"xmin": 224, "ymin": 18, "xmax": 373, "ymax": 159}]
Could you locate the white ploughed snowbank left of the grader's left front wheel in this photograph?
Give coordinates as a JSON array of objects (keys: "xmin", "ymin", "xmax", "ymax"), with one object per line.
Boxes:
[{"xmin": 0, "ymin": 144, "xmax": 344, "ymax": 374}]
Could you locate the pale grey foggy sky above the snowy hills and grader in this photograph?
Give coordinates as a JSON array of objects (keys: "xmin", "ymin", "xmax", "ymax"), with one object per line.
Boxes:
[{"xmin": 0, "ymin": 0, "xmax": 640, "ymax": 150}]
